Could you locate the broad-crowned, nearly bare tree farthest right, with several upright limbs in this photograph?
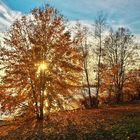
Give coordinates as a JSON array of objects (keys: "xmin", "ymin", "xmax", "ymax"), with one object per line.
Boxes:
[{"xmin": 104, "ymin": 28, "xmax": 136, "ymax": 103}]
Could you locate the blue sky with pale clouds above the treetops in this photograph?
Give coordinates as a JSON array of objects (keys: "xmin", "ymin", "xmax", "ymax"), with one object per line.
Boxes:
[{"xmin": 0, "ymin": 0, "xmax": 140, "ymax": 40}]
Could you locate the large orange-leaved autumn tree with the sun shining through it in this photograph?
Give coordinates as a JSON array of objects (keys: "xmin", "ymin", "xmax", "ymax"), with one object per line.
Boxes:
[{"xmin": 0, "ymin": 5, "xmax": 82, "ymax": 119}]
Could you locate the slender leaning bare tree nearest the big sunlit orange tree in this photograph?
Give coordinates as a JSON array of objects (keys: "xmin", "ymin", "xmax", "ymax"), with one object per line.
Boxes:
[{"xmin": 75, "ymin": 22, "xmax": 93, "ymax": 107}]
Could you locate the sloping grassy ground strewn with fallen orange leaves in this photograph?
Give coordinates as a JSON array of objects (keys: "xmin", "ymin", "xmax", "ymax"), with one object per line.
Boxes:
[{"xmin": 0, "ymin": 103, "xmax": 140, "ymax": 140}]
